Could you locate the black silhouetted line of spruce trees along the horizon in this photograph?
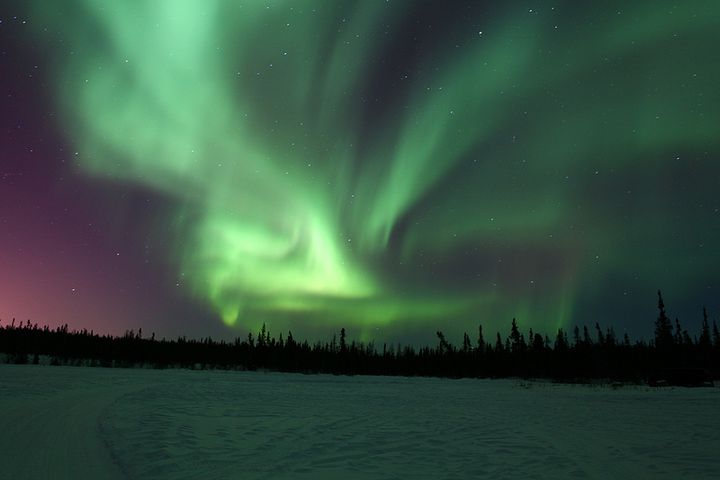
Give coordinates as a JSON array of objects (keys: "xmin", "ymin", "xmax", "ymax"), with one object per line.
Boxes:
[{"xmin": 0, "ymin": 292, "xmax": 720, "ymax": 385}]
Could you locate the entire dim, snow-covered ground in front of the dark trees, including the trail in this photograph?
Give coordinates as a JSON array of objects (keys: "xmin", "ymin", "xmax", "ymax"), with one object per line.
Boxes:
[{"xmin": 0, "ymin": 365, "xmax": 720, "ymax": 480}]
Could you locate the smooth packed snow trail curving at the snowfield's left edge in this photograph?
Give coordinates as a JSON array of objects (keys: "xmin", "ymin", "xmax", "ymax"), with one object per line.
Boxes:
[{"xmin": 0, "ymin": 365, "xmax": 152, "ymax": 480}]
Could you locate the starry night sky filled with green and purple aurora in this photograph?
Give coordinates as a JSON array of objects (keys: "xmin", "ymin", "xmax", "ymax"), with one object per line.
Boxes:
[{"xmin": 0, "ymin": 0, "xmax": 720, "ymax": 343}]
